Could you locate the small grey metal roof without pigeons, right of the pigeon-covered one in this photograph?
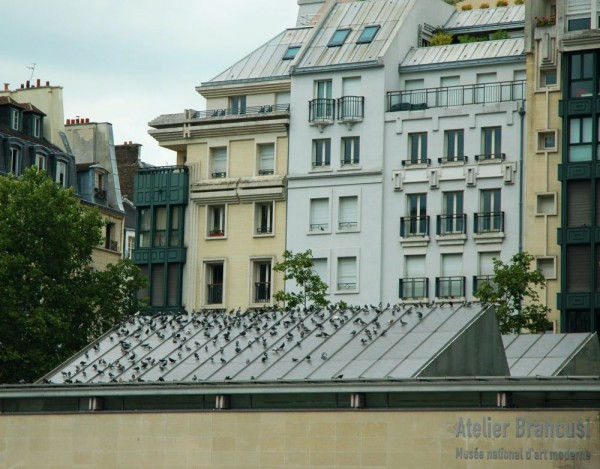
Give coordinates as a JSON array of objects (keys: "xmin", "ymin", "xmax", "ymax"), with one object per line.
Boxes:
[{"xmin": 502, "ymin": 333, "xmax": 600, "ymax": 376}]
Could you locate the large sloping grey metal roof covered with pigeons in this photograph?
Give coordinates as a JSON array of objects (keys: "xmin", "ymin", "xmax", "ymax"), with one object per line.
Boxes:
[{"xmin": 43, "ymin": 303, "xmax": 508, "ymax": 384}]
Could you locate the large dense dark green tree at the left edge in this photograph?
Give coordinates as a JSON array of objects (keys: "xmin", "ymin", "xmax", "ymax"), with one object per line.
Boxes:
[{"xmin": 0, "ymin": 168, "xmax": 145, "ymax": 383}]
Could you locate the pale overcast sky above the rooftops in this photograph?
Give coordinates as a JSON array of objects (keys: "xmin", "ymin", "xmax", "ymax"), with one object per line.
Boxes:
[{"xmin": 0, "ymin": 0, "xmax": 298, "ymax": 164}]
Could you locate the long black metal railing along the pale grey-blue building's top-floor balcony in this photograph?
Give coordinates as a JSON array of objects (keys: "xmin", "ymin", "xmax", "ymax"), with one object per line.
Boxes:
[{"xmin": 387, "ymin": 80, "xmax": 525, "ymax": 112}]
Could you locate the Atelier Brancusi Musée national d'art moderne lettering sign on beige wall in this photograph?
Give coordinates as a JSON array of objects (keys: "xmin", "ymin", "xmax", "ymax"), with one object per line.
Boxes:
[{"xmin": 449, "ymin": 411, "xmax": 600, "ymax": 469}]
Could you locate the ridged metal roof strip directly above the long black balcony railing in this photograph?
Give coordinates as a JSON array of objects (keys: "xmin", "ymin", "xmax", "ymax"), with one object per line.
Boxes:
[{"xmin": 400, "ymin": 38, "xmax": 524, "ymax": 68}]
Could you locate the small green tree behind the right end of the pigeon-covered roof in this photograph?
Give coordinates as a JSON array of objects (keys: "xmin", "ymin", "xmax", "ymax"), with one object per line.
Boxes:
[{"xmin": 475, "ymin": 252, "xmax": 550, "ymax": 334}]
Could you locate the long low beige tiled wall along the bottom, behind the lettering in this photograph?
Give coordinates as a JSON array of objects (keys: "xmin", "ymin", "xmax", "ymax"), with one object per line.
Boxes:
[{"xmin": 0, "ymin": 410, "xmax": 600, "ymax": 469}]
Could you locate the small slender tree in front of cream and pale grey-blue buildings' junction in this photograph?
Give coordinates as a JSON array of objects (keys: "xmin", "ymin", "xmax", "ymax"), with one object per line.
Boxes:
[{"xmin": 273, "ymin": 249, "xmax": 329, "ymax": 308}]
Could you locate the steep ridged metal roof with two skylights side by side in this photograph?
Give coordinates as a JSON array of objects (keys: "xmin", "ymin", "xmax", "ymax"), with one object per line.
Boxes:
[{"xmin": 295, "ymin": 0, "xmax": 414, "ymax": 70}]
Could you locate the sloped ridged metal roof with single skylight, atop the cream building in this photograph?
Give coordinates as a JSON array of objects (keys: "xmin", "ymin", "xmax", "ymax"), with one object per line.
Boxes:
[{"xmin": 203, "ymin": 28, "xmax": 312, "ymax": 85}]
